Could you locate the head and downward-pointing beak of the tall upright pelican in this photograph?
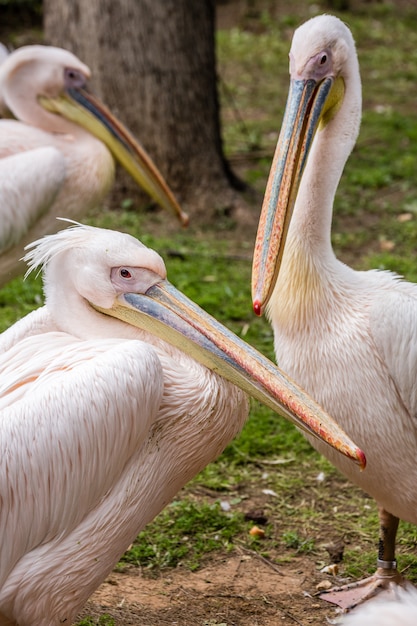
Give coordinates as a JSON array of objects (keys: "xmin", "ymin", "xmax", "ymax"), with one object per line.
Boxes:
[{"xmin": 252, "ymin": 15, "xmax": 361, "ymax": 315}]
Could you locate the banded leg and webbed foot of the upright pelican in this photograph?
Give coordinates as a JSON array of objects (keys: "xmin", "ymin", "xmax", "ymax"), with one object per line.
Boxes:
[{"xmin": 319, "ymin": 507, "xmax": 407, "ymax": 610}]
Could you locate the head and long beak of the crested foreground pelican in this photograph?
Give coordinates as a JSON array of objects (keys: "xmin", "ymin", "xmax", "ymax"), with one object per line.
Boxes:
[{"xmin": 25, "ymin": 217, "xmax": 365, "ymax": 467}]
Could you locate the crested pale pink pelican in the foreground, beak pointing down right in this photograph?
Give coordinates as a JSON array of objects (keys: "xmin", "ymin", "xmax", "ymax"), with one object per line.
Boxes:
[{"xmin": 0, "ymin": 225, "xmax": 365, "ymax": 626}]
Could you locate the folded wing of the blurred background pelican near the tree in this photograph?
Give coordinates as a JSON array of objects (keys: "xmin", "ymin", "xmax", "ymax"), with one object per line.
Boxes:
[{"xmin": 0, "ymin": 147, "xmax": 65, "ymax": 255}]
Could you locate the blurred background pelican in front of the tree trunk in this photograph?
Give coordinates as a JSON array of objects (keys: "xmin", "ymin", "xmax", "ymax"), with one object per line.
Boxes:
[{"xmin": 0, "ymin": 46, "xmax": 188, "ymax": 286}]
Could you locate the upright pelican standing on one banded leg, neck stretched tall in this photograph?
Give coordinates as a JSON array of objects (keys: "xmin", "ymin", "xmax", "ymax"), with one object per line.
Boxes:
[{"xmin": 252, "ymin": 15, "xmax": 417, "ymax": 608}]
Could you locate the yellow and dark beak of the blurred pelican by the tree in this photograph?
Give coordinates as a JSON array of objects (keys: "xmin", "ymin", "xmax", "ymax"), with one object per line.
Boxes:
[{"xmin": 39, "ymin": 87, "xmax": 189, "ymax": 226}]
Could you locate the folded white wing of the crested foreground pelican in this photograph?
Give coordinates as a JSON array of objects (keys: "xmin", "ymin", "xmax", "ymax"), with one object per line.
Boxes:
[{"xmin": 0, "ymin": 332, "xmax": 163, "ymax": 588}]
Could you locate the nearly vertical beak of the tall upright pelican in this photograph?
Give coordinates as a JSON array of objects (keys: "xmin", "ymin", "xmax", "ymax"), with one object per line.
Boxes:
[{"xmin": 252, "ymin": 77, "xmax": 345, "ymax": 315}]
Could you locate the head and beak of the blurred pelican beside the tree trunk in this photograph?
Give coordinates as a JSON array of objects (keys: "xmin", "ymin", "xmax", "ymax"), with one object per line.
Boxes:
[{"xmin": 0, "ymin": 45, "xmax": 188, "ymax": 225}]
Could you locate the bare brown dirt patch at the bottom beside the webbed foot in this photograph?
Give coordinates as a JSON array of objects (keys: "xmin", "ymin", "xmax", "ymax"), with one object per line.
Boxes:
[{"xmin": 78, "ymin": 551, "xmax": 344, "ymax": 626}]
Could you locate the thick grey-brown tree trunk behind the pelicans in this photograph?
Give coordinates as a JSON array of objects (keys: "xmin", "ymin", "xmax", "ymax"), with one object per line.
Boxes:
[{"xmin": 44, "ymin": 0, "xmax": 239, "ymax": 222}]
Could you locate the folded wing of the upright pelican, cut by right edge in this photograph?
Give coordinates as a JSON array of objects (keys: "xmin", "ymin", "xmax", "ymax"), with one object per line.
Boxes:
[{"xmin": 370, "ymin": 282, "xmax": 417, "ymax": 419}]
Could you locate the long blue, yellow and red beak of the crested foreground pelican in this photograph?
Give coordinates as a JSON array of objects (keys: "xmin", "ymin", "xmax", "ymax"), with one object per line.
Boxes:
[{"xmin": 94, "ymin": 280, "xmax": 366, "ymax": 469}]
